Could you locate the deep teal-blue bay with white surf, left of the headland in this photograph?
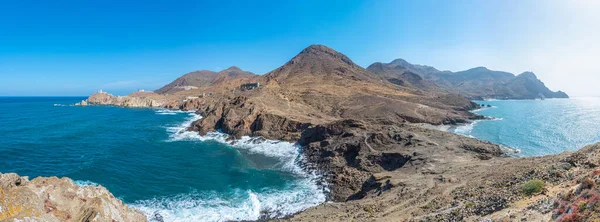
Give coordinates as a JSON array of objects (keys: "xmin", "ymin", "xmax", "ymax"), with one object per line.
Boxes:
[{"xmin": 0, "ymin": 97, "xmax": 325, "ymax": 221}]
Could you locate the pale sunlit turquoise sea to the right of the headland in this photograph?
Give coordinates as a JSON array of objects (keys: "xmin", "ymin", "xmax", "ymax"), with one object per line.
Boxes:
[{"xmin": 453, "ymin": 98, "xmax": 600, "ymax": 156}]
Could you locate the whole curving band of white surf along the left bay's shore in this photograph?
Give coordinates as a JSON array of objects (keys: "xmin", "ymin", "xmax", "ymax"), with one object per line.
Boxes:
[{"xmin": 138, "ymin": 113, "xmax": 327, "ymax": 221}]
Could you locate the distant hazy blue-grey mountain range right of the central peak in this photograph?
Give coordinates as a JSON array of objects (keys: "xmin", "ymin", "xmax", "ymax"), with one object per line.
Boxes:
[{"xmin": 368, "ymin": 59, "xmax": 568, "ymax": 99}]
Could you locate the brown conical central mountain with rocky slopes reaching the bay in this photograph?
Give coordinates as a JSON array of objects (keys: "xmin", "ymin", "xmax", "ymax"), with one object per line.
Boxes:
[{"xmin": 186, "ymin": 45, "xmax": 481, "ymax": 140}]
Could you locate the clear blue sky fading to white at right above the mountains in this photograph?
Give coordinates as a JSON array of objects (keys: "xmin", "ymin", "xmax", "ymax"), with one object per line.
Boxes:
[{"xmin": 0, "ymin": 0, "xmax": 600, "ymax": 96}]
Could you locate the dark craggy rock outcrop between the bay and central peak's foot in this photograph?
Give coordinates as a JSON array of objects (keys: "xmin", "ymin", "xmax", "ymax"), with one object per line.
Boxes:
[{"xmin": 298, "ymin": 120, "xmax": 503, "ymax": 201}]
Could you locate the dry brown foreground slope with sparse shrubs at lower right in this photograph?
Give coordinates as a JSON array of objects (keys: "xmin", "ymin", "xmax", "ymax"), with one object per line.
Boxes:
[{"xmin": 285, "ymin": 144, "xmax": 600, "ymax": 221}]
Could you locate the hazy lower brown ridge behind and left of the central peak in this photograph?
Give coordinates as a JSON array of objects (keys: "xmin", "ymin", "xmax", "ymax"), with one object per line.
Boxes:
[{"xmin": 155, "ymin": 66, "xmax": 255, "ymax": 94}]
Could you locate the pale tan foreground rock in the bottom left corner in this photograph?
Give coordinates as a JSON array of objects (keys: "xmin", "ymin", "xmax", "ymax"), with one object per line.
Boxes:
[{"xmin": 0, "ymin": 173, "xmax": 147, "ymax": 222}]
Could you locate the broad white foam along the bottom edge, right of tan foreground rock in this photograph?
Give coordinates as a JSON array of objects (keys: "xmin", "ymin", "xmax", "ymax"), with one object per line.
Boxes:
[{"xmin": 132, "ymin": 181, "xmax": 324, "ymax": 222}]
